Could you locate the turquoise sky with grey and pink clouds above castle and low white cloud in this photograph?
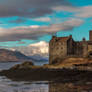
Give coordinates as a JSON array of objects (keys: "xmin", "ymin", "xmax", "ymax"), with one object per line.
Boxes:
[{"xmin": 0, "ymin": 0, "xmax": 92, "ymax": 48}]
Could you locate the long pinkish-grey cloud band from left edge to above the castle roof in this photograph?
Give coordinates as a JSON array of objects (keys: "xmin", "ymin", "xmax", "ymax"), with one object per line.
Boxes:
[{"xmin": 0, "ymin": 18, "xmax": 83, "ymax": 42}]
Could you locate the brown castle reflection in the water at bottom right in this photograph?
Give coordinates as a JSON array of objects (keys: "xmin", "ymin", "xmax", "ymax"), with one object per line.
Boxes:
[{"xmin": 48, "ymin": 83, "xmax": 92, "ymax": 92}]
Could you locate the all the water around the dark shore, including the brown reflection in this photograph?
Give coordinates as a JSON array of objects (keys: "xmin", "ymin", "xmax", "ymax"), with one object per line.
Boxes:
[{"xmin": 0, "ymin": 62, "xmax": 92, "ymax": 92}]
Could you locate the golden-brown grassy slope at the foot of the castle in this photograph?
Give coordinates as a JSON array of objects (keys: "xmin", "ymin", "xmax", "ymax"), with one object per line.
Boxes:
[{"xmin": 50, "ymin": 57, "xmax": 92, "ymax": 70}]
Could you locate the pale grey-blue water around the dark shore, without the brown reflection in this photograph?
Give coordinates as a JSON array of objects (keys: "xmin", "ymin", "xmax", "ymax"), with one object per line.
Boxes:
[{"xmin": 0, "ymin": 62, "xmax": 49, "ymax": 92}]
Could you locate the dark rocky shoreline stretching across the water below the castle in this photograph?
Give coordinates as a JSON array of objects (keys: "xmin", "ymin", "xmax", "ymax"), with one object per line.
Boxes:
[{"xmin": 0, "ymin": 62, "xmax": 92, "ymax": 83}]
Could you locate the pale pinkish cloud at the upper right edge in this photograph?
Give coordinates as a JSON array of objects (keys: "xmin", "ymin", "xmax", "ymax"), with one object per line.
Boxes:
[{"xmin": 53, "ymin": 6, "xmax": 92, "ymax": 18}]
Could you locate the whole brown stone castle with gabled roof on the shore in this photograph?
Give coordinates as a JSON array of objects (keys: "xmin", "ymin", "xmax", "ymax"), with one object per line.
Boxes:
[{"xmin": 49, "ymin": 31, "xmax": 92, "ymax": 64}]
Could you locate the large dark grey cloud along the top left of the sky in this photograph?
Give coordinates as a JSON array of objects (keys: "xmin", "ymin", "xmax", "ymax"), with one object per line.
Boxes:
[{"xmin": 0, "ymin": 0, "xmax": 71, "ymax": 17}]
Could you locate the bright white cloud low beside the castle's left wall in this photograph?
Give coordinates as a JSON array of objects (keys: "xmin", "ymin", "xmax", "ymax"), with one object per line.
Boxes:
[{"xmin": 8, "ymin": 41, "xmax": 49, "ymax": 57}]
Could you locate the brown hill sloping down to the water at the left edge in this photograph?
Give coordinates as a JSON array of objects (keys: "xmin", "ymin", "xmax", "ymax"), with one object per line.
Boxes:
[{"xmin": 0, "ymin": 49, "xmax": 29, "ymax": 62}]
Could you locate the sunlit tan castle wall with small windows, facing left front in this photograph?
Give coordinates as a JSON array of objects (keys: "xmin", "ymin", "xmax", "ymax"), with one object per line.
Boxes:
[{"xmin": 49, "ymin": 37, "xmax": 67, "ymax": 64}]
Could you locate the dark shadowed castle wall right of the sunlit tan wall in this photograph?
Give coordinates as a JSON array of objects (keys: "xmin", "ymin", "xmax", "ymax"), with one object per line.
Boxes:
[{"xmin": 67, "ymin": 39, "xmax": 86, "ymax": 57}]
